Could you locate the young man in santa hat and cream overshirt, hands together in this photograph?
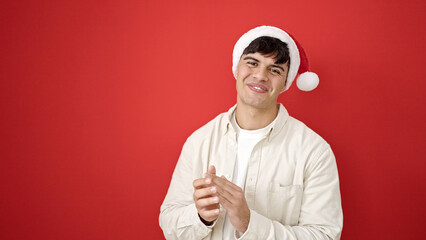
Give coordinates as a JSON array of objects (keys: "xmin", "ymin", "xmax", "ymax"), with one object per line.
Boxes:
[{"xmin": 160, "ymin": 26, "xmax": 343, "ymax": 239}]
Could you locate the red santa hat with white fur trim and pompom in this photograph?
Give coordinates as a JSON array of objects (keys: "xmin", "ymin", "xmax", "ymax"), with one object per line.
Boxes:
[{"xmin": 232, "ymin": 26, "xmax": 319, "ymax": 91}]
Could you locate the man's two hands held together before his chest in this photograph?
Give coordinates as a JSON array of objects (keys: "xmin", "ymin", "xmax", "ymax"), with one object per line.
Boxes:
[{"xmin": 193, "ymin": 166, "xmax": 250, "ymax": 233}]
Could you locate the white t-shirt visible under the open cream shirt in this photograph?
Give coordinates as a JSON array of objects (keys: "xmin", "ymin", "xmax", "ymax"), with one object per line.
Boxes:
[{"xmin": 223, "ymin": 112, "xmax": 276, "ymax": 240}]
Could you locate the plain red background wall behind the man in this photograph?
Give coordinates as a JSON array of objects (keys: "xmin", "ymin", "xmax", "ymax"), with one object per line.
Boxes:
[{"xmin": 0, "ymin": 0, "xmax": 426, "ymax": 240}]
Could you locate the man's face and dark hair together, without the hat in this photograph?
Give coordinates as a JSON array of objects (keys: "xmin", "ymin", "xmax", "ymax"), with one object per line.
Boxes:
[{"xmin": 234, "ymin": 36, "xmax": 290, "ymax": 109}]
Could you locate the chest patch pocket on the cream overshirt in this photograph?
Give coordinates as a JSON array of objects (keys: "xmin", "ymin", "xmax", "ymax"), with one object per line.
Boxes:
[{"xmin": 267, "ymin": 182, "xmax": 302, "ymax": 226}]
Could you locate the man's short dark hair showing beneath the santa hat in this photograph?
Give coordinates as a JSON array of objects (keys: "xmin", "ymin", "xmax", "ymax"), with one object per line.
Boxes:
[{"xmin": 243, "ymin": 36, "xmax": 290, "ymax": 66}]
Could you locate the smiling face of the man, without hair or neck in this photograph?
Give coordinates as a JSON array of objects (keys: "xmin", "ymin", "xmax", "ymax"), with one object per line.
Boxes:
[{"xmin": 235, "ymin": 53, "xmax": 288, "ymax": 109}]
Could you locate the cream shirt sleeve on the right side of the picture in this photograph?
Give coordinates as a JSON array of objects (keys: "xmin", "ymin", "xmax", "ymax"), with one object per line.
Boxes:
[{"xmin": 238, "ymin": 147, "xmax": 343, "ymax": 240}]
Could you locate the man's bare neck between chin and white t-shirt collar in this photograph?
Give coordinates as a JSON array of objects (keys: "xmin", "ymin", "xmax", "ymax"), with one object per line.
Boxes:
[{"xmin": 235, "ymin": 104, "xmax": 279, "ymax": 130}]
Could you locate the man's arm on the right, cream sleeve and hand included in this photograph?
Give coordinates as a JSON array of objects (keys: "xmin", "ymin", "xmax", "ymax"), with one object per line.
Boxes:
[{"xmin": 212, "ymin": 148, "xmax": 343, "ymax": 240}]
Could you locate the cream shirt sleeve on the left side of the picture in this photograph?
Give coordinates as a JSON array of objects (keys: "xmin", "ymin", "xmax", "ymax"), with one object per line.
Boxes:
[{"xmin": 159, "ymin": 139, "xmax": 214, "ymax": 239}]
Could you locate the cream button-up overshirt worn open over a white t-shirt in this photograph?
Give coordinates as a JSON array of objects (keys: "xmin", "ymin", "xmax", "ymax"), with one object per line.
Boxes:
[{"xmin": 159, "ymin": 105, "xmax": 343, "ymax": 240}]
